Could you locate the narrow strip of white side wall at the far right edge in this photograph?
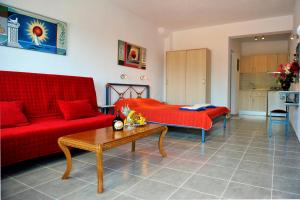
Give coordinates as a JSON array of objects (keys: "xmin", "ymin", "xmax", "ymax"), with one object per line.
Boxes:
[{"xmin": 290, "ymin": 0, "xmax": 300, "ymax": 141}]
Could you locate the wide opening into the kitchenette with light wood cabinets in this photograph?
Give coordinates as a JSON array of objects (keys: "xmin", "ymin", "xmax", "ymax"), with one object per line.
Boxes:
[{"xmin": 228, "ymin": 33, "xmax": 290, "ymax": 116}]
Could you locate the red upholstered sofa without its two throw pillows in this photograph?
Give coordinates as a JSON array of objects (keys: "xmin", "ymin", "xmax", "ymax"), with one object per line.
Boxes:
[{"xmin": 0, "ymin": 71, "xmax": 114, "ymax": 166}]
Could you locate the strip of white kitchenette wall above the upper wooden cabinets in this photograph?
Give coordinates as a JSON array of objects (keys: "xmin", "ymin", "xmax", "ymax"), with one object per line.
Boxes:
[{"xmin": 241, "ymin": 40, "xmax": 289, "ymax": 56}]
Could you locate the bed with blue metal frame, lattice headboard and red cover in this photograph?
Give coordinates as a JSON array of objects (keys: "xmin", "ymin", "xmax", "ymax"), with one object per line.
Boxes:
[{"xmin": 106, "ymin": 83, "xmax": 229, "ymax": 143}]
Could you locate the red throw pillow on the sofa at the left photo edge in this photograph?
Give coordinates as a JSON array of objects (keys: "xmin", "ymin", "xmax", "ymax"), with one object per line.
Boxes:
[{"xmin": 0, "ymin": 101, "xmax": 29, "ymax": 128}]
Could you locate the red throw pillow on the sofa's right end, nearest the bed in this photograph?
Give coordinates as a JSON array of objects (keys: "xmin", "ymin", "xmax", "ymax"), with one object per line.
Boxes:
[{"xmin": 57, "ymin": 99, "xmax": 97, "ymax": 120}]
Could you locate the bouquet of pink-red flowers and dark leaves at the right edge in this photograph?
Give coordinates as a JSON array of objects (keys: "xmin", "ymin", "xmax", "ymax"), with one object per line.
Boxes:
[{"xmin": 275, "ymin": 62, "xmax": 299, "ymax": 91}]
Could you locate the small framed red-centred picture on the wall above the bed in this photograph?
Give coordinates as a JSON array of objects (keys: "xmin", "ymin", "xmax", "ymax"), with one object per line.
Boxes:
[{"xmin": 118, "ymin": 40, "xmax": 146, "ymax": 69}]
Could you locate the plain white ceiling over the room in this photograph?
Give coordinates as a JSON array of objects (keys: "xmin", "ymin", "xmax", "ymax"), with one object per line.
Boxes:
[{"xmin": 111, "ymin": 0, "xmax": 294, "ymax": 30}]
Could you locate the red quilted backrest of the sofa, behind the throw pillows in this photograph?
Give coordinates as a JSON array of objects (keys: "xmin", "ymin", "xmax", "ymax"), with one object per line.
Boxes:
[{"xmin": 0, "ymin": 71, "xmax": 97, "ymax": 118}]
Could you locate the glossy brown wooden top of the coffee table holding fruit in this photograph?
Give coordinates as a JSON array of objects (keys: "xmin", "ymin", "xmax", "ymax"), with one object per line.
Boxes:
[{"xmin": 62, "ymin": 124, "xmax": 164, "ymax": 145}]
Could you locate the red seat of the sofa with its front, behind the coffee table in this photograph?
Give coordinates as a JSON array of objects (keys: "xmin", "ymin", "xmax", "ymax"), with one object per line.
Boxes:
[{"xmin": 1, "ymin": 112, "xmax": 114, "ymax": 165}]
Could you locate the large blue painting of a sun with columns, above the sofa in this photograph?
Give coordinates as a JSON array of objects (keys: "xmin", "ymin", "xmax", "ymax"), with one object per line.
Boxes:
[{"xmin": 0, "ymin": 4, "xmax": 67, "ymax": 55}]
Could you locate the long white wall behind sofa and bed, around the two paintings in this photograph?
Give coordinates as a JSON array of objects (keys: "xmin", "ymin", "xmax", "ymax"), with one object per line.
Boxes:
[{"xmin": 0, "ymin": 0, "xmax": 164, "ymax": 104}]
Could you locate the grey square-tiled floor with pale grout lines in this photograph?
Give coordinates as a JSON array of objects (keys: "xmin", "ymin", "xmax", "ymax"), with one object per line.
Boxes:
[{"xmin": 1, "ymin": 118, "xmax": 300, "ymax": 200}]
